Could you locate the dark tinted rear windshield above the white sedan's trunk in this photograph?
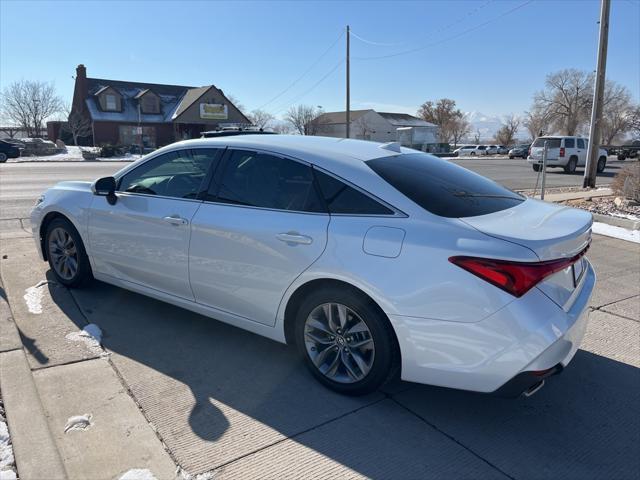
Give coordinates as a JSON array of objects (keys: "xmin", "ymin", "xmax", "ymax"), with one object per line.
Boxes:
[{"xmin": 367, "ymin": 153, "xmax": 524, "ymax": 218}]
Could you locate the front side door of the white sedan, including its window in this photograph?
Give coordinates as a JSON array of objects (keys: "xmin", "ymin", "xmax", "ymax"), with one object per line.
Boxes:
[{"xmin": 89, "ymin": 149, "xmax": 220, "ymax": 300}]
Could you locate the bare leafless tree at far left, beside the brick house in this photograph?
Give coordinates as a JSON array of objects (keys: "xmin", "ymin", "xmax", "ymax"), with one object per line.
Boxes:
[{"xmin": 2, "ymin": 80, "xmax": 62, "ymax": 137}]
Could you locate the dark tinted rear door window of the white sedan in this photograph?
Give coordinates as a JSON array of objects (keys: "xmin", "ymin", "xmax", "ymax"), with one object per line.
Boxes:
[{"xmin": 217, "ymin": 150, "xmax": 326, "ymax": 213}]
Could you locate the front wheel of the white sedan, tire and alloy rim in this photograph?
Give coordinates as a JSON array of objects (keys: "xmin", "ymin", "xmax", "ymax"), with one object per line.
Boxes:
[{"xmin": 44, "ymin": 218, "xmax": 93, "ymax": 288}]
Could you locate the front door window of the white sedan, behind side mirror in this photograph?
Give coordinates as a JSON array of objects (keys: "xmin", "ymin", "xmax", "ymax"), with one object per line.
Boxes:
[{"xmin": 118, "ymin": 149, "xmax": 216, "ymax": 198}]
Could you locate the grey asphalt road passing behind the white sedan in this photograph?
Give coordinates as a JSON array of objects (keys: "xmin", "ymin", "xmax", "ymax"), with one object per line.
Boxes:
[{"xmin": 0, "ymin": 157, "xmax": 629, "ymax": 220}]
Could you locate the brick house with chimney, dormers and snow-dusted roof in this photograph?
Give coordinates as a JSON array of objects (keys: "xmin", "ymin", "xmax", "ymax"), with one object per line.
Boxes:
[{"xmin": 67, "ymin": 65, "xmax": 251, "ymax": 148}]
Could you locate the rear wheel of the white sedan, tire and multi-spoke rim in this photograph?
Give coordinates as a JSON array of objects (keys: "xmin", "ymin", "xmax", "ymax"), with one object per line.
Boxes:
[{"xmin": 295, "ymin": 287, "xmax": 399, "ymax": 395}]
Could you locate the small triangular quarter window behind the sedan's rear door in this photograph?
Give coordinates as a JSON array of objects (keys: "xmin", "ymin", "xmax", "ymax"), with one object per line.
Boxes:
[{"xmin": 314, "ymin": 169, "xmax": 394, "ymax": 215}]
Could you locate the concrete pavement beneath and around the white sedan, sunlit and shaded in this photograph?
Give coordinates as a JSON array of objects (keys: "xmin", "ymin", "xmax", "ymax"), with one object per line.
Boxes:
[{"xmin": 0, "ymin": 236, "xmax": 640, "ymax": 480}]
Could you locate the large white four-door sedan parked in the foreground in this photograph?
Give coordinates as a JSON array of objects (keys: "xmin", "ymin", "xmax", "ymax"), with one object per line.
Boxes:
[{"xmin": 31, "ymin": 135, "xmax": 595, "ymax": 395}]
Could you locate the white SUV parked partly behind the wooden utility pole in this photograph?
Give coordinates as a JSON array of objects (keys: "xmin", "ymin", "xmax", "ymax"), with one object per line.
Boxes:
[{"xmin": 527, "ymin": 136, "xmax": 607, "ymax": 173}]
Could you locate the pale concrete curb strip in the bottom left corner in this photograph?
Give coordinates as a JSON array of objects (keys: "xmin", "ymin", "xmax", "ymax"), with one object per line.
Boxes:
[{"xmin": 0, "ymin": 274, "xmax": 67, "ymax": 480}]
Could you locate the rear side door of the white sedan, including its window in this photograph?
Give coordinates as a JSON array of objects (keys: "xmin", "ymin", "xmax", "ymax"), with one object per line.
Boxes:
[{"xmin": 189, "ymin": 149, "xmax": 330, "ymax": 325}]
